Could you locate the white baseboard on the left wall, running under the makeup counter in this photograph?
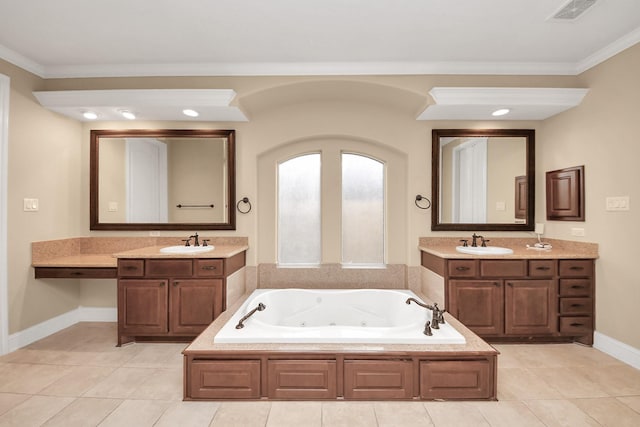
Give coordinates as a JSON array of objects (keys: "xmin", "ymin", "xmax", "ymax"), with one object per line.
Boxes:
[{"xmin": 9, "ymin": 307, "xmax": 118, "ymax": 352}]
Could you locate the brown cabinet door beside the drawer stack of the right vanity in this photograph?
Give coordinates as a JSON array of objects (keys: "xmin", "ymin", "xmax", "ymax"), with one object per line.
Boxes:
[{"xmin": 504, "ymin": 280, "xmax": 557, "ymax": 335}]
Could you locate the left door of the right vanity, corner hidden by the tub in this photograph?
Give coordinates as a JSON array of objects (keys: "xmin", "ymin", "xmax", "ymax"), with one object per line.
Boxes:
[{"xmin": 448, "ymin": 280, "xmax": 504, "ymax": 335}]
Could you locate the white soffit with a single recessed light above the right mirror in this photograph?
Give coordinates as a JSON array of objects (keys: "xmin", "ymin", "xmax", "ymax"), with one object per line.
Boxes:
[{"xmin": 418, "ymin": 87, "xmax": 589, "ymax": 120}]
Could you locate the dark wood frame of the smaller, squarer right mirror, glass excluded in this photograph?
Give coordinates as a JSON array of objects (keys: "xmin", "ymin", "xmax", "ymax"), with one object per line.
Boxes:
[{"xmin": 431, "ymin": 129, "xmax": 536, "ymax": 231}]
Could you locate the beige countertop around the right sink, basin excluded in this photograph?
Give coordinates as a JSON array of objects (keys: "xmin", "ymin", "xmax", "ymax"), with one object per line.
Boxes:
[{"xmin": 418, "ymin": 237, "xmax": 598, "ymax": 259}]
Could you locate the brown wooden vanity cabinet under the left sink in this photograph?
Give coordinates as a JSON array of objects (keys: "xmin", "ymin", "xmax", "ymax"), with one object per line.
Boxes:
[{"xmin": 118, "ymin": 252, "xmax": 244, "ymax": 345}]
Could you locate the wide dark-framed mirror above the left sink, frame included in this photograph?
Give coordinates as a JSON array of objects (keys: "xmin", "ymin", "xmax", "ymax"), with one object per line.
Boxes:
[{"xmin": 89, "ymin": 129, "xmax": 236, "ymax": 230}]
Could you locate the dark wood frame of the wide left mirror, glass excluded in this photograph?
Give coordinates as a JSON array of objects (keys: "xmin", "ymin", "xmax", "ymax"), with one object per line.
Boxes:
[{"xmin": 89, "ymin": 129, "xmax": 236, "ymax": 231}]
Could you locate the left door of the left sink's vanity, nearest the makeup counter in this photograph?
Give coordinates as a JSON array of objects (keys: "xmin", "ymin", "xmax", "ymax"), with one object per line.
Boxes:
[{"xmin": 118, "ymin": 279, "xmax": 169, "ymax": 335}]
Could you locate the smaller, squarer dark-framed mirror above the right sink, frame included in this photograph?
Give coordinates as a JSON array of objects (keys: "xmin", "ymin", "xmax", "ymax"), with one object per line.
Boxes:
[{"xmin": 431, "ymin": 129, "xmax": 535, "ymax": 231}]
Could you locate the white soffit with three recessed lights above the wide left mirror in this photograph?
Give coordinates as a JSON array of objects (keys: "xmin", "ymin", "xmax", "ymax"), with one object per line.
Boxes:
[{"xmin": 33, "ymin": 89, "xmax": 248, "ymax": 122}]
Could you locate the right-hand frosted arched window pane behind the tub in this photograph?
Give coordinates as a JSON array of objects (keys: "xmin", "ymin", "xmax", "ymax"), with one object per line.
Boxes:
[{"xmin": 342, "ymin": 154, "xmax": 384, "ymax": 264}]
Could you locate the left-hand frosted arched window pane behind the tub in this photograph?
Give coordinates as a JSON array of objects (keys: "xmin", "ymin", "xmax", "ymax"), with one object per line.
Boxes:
[{"xmin": 278, "ymin": 154, "xmax": 321, "ymax": 264}]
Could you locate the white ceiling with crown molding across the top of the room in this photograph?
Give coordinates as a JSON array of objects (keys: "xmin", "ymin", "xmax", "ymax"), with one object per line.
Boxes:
[{"xmin": 0, "ymin": 0, "xmax": 640, "ymax": 78}]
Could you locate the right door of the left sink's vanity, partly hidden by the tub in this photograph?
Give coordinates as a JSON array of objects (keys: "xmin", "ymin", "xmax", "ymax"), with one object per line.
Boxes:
[{"xmin": 169, "ymin": 279, "xmax": 222, "ymax": 335}]
